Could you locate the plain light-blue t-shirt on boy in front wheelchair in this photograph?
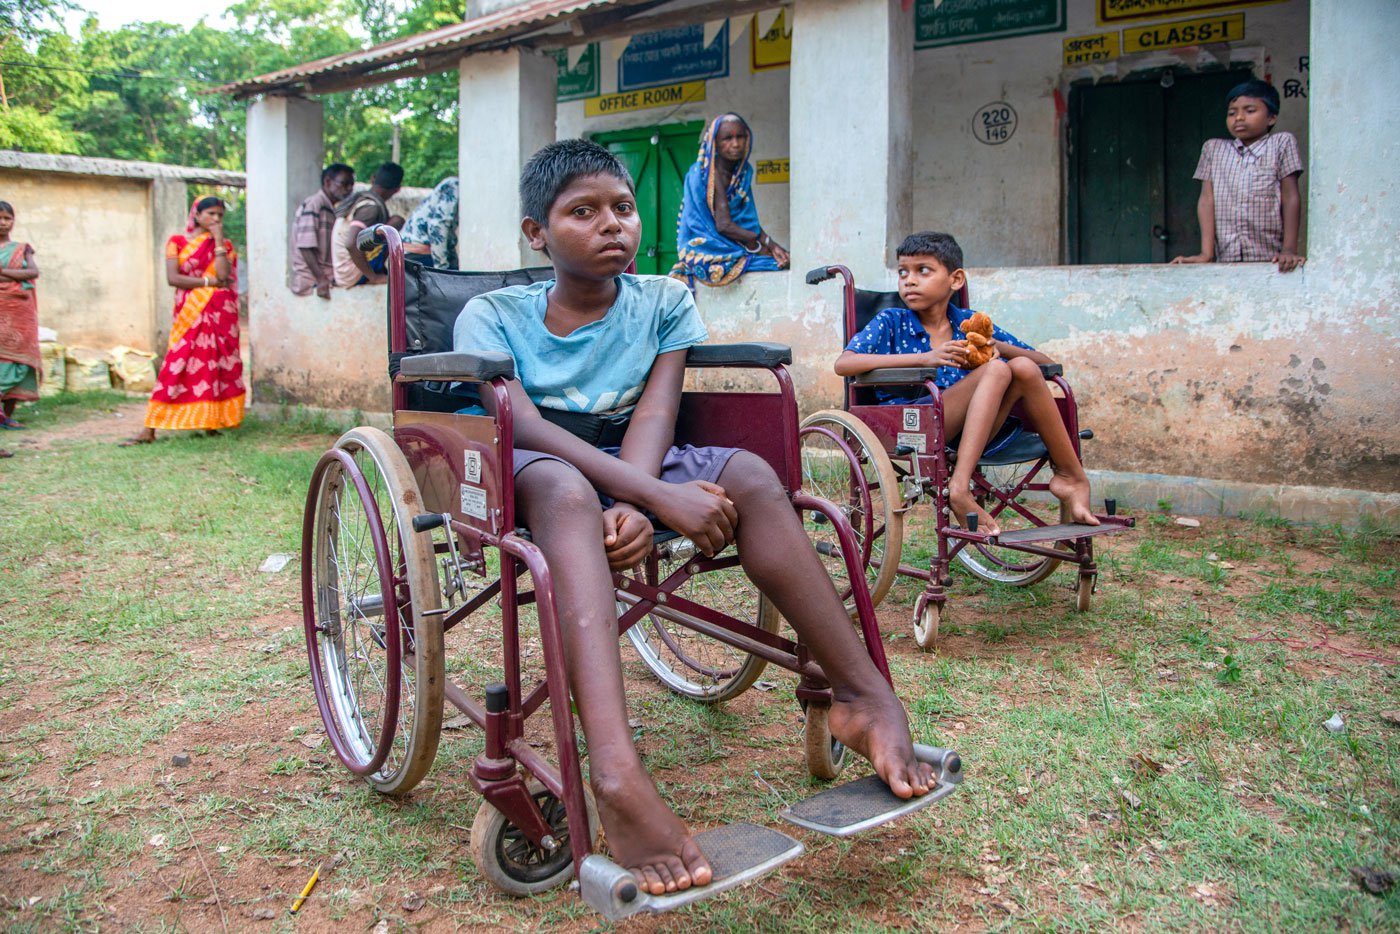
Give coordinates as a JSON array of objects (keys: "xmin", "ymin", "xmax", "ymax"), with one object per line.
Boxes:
[{"xmin": 452, "ymin": 274, "xmax": 708, "ymax": 414}]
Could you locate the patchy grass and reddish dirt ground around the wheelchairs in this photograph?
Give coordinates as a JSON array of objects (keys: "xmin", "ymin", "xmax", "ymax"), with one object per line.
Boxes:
[{"xmin": 0, "ymin": 396, "xmax": 1400, "ymax": 931}]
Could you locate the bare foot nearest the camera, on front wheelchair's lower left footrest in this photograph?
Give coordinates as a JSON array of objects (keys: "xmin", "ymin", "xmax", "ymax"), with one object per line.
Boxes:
[{"xmin": 592, "ymin": 763, "xmax": 714, "ymax": 895}]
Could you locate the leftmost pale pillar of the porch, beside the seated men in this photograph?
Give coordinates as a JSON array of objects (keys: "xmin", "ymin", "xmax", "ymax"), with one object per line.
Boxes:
[{"xmin": 239, "ymin": 97, "xmax": 325, "ymax": 393}]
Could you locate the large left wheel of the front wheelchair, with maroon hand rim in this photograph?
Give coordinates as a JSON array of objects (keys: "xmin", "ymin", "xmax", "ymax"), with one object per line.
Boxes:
[{"xmin": 301, "ymin": 427, "xmax": 444, "ymax": 794}]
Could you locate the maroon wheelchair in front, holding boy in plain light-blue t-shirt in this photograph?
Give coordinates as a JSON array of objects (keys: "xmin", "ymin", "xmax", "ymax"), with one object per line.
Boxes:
[{"xmin": 302, "ymin": 227, "xmax": 962, "ymax": 920}]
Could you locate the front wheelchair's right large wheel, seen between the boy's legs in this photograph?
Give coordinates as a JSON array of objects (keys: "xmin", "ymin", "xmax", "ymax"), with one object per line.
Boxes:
[{"xmin": 627, "ymin": 542, "xmax": 783, "ymax": 704}]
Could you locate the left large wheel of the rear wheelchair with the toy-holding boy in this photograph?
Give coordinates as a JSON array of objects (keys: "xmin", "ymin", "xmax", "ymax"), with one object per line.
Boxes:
[{"xmin": 799, "ymin": 409, "xmax": 904, "ymax": 613}]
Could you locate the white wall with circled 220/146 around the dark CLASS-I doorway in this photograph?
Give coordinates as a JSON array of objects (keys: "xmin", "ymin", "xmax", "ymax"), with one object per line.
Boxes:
[{"xmin": 912, "ymin": 0, "xmax": 1309, "ymax": 266}]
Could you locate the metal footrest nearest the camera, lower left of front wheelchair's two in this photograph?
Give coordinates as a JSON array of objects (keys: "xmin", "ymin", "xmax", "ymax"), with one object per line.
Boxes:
[{"xmin": 578, "ymin": 823, "xmax": 806, "ymax": 921}]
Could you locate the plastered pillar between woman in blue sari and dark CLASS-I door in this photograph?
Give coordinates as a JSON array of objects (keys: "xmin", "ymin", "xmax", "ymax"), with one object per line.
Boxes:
[{"xmin": 790, "ymin": 0, "xmax": 914, "ymax": 286}]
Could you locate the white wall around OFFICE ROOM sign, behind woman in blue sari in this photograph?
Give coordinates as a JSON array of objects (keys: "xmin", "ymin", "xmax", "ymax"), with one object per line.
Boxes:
[{"xmin": 556, "ymin": 15, "xmax": 800, "ymax": 256}]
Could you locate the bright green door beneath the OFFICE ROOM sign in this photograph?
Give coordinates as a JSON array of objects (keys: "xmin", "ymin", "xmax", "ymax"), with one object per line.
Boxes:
[{"xmin": 594, "ymin": 122, "xmax": 704, "ymax": 274}]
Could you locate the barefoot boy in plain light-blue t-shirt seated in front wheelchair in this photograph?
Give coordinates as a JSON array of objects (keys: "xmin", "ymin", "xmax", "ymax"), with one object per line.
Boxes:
[{"xmin": 454, "ymin": 140, "xmax": 934, "ymax": 895}]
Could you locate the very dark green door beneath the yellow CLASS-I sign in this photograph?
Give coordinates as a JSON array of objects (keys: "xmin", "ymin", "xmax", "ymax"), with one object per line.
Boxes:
[{"xmin": 1068, "ymin": 70, "xmax": 1250, "ymax": 263}]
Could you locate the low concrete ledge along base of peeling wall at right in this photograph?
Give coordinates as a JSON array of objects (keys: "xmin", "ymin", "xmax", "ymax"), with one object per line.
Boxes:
[{"xmin": 1089, "ymin": 471, "xmax": 1400, "ymax": 534}]
